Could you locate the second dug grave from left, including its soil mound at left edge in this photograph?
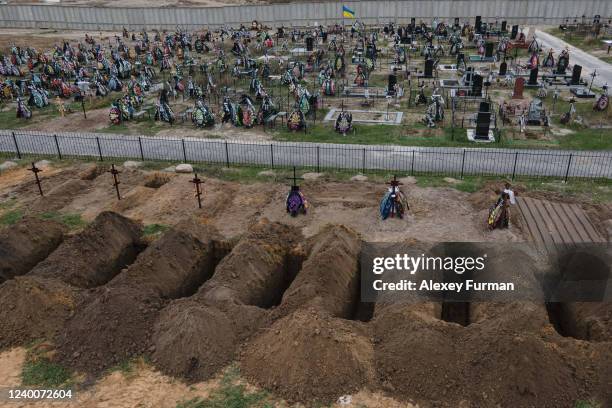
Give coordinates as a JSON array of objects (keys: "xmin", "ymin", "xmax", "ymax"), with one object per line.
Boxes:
[{"xmin": 0, "ymin": 213, "xmax": 140, "ymax": 347}]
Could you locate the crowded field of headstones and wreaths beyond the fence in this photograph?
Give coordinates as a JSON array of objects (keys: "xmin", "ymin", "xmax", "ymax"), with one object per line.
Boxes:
[{"xmin": 0, "ymin": 16, "xmax": 608, "ymax": 142}]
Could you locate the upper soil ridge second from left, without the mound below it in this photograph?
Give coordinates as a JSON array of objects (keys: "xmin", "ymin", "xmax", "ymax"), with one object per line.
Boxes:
[{"xmin": 30, "ymin": 212, "xmax": 142, "ymax": 288}]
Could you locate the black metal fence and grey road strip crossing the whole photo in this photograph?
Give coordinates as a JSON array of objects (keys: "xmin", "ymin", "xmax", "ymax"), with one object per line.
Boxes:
[{"xmin": 0, "ymin": 130, "xmax": 612, "ymax": 180}]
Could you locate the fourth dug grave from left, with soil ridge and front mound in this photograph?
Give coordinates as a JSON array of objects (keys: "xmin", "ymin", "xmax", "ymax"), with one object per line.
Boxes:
[{"xmin": 153, "ymin": 220, "xmax": 299, "ymax": 381}]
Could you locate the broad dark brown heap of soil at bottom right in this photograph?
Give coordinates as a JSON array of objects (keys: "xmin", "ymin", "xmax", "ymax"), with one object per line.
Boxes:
[{"xmin": 374, "ymin": 306, "xmax": 592, "ymax": 407}]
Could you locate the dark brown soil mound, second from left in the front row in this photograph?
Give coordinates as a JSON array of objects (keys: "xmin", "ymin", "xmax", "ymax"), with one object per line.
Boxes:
[{"xmin": 57, "ymin": 286, "xmax": 164, "ymax": 375}]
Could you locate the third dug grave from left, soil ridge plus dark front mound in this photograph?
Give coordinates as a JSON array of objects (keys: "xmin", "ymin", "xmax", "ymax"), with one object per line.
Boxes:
[{"xmin": 58, "ymin": 220, "xmax": 222, "ymax": 375}]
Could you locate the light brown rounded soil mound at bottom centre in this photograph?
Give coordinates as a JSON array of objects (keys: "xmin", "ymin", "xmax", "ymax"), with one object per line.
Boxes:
[{"xmin": 240, "ymin": 310, "xmax": 374, "ymax": 403}]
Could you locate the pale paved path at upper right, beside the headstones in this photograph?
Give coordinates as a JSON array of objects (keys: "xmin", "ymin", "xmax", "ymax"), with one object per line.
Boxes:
[{"xmin": 535, "ymin": 30, "xmax": 612, "ymax": 87}]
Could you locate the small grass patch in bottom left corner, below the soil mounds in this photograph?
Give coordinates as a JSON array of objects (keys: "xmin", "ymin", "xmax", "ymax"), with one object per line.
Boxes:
[{"xmin": 21, "ymin": 343, "xmax": 72, "ymax": 388}]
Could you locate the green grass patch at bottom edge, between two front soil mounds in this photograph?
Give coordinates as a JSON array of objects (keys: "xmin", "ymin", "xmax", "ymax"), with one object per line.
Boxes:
[{"xmin": 176, "ymin": 366, "xmax": 274, "ymax": 408}]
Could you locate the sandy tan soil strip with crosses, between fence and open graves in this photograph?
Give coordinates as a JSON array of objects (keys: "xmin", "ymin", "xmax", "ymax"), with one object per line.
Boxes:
[{"xmin": 0, "ymin": 160, "xmax": 524, "ymax": 242}]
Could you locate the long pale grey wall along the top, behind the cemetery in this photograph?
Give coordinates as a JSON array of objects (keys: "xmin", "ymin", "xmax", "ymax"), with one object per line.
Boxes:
[{"xmin": 0, "ymin": 0, "xmax": 612, "ymax": 31}]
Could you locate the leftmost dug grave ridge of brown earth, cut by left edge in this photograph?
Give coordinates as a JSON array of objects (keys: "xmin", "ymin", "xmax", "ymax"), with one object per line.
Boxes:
[{"xmin": 0, "ymin": 218, "xmax": 67, "ymax": 283}]
